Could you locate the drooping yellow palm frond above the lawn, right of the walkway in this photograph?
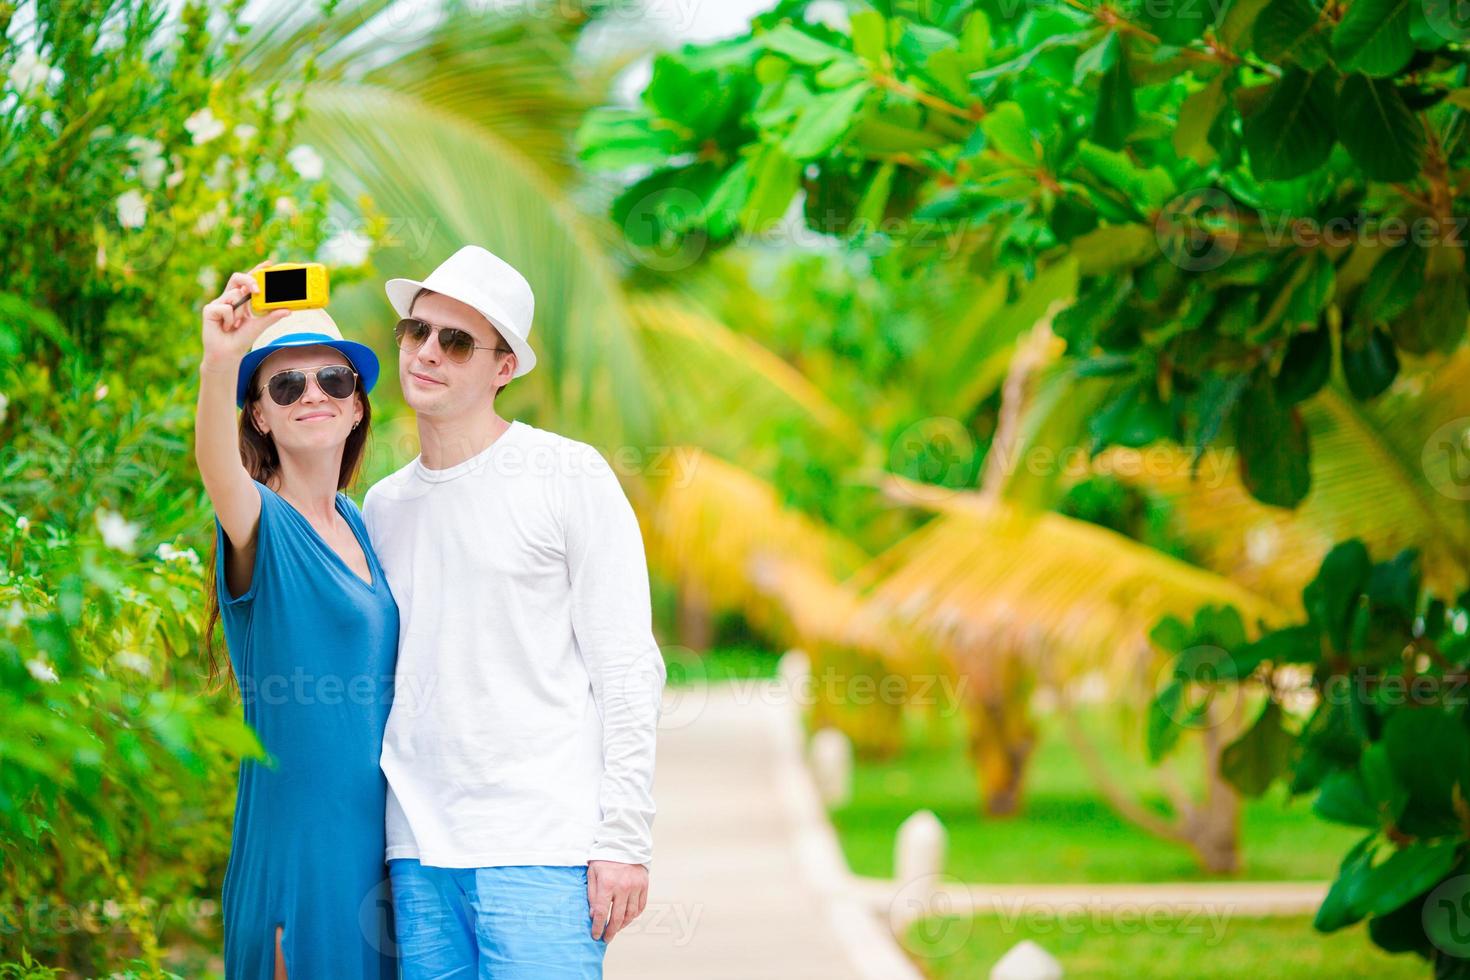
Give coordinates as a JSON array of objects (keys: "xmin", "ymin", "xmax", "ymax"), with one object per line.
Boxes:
[{"xmin": 851, "ymin": 478, "xmax": 1286, "ymax": 683}]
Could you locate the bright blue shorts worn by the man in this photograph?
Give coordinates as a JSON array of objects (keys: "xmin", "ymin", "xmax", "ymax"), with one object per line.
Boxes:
[{"xmin": 388, "ymin": 858, "xmax": 607, "ymax": 980}]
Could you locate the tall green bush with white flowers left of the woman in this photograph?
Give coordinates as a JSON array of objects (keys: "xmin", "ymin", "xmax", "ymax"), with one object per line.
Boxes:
[{"xmin": 0, "ymin": 0, "xmax": 379, "ymax": 977}]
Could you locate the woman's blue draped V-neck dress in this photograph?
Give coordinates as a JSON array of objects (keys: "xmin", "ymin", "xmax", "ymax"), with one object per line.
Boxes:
[{"xmin": 215, "ymin": 480, "xmax": 398, "ymax": 980}]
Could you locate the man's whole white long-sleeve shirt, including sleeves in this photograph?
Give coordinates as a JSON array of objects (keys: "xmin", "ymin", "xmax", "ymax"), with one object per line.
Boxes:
[{"xmin": 363, "ymin": 420, "xmax": 664, "ymax": 868}]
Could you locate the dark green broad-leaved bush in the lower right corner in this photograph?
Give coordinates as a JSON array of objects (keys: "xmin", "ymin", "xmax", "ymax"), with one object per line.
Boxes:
[{"xmin": 1148, "ymin": 541, "xmax": 1470, "ymax": 977}]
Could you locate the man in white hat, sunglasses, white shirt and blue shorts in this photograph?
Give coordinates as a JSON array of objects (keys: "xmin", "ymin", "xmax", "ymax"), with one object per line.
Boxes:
[{"xmin": 363, "ymin": 245, "xmax": 664, "ymax": 980}]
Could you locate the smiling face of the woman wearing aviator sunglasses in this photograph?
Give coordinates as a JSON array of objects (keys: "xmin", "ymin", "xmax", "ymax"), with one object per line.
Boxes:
[{"xmin": 250, "ymin": 347, "xmax": 363, "ymax": 453}]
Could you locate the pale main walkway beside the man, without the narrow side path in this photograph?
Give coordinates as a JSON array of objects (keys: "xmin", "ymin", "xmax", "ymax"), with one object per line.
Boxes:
[{"xmin": 606, "ymin": 682, "xmax": 917, "ymax": 980}]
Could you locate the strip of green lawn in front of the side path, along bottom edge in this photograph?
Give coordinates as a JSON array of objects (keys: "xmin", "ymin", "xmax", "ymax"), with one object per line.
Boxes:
[{"xmin": 906, "ymin": 909, "xmax": 1433, "ymax": 980}]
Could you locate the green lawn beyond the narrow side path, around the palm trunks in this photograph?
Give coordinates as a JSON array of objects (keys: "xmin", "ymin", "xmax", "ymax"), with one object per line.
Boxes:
[{"xmin": 832, "ymin": 702, "xmax": 1360, "ymax": 883}]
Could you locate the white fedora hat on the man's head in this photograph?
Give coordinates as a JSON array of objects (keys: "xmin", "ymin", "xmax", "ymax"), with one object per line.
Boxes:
[{"xmin": 384, "ymin": 245, "xmax": 537, "ymax": 378}]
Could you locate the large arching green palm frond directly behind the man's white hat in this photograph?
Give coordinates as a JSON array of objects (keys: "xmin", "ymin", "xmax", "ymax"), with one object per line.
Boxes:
[{"xmin": 298, "ymin": 84, "xmax": 657, "ymax": 447}]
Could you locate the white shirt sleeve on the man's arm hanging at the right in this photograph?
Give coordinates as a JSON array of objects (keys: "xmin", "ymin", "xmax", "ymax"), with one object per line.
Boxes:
[{"xmin": 563, "ymin": 447, "xmax": 666, "ymax": 864}]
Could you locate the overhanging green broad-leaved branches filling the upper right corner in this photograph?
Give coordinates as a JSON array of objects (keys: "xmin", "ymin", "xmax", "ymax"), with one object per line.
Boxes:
[{"xmin": 579, "ymin": 0, "xmax": 1470, "ymax": 507}]
